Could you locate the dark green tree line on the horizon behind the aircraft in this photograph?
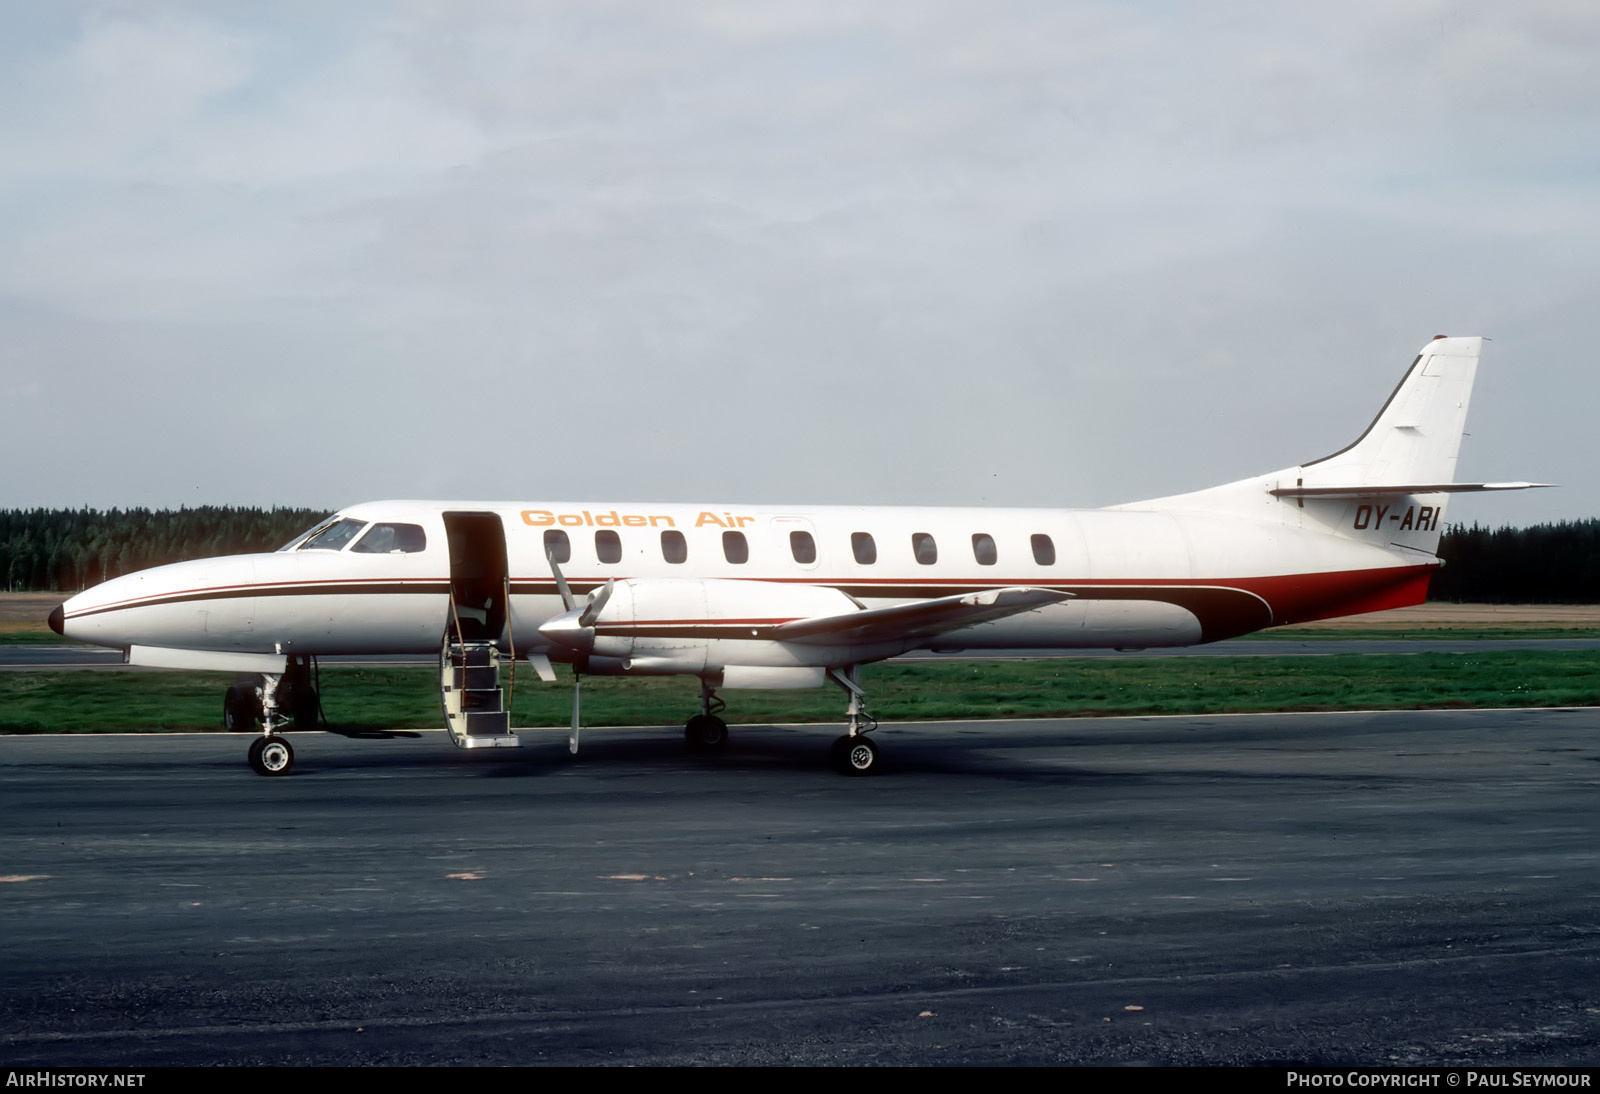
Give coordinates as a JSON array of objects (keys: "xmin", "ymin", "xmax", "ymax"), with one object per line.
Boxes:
[{"xmin": 0, "ymin": 505, "xmax": 1600, "ymax": 605}]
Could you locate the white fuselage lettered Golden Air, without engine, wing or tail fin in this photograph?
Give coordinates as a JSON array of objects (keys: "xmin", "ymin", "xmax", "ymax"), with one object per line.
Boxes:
[{"xmin": 62, "ymin": 499, "xmax": 1437, "ymax": 654}]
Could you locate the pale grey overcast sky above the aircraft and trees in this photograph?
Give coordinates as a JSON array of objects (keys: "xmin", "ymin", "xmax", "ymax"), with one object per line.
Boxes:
[{"xmin": 0, "ymin": 0, "xmax": 1600, "ymax": 525}]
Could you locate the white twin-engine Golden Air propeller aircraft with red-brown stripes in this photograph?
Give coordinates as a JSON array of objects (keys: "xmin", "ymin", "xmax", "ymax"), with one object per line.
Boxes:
[{"xmin": 50, "ymin": 336, "xmax": 1534, "ymax": 776}]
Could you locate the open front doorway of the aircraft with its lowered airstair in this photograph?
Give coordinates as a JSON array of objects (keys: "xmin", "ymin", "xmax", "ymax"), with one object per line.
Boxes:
[{"xmin": 438, "ymin": 512, "xmax": 520, "ymax": 749}]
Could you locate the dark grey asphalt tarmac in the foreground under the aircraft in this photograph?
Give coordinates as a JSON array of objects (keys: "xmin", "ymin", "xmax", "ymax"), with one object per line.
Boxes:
[{"xmin": 0, "ymin": 709, "xmax": 1600, "ymax": 1067}]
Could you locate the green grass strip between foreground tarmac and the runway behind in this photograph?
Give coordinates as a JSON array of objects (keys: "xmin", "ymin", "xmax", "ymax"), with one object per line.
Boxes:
[{"xmin": 0, "ymin": 649, "xmax": 1600, "ymax": 734}]
